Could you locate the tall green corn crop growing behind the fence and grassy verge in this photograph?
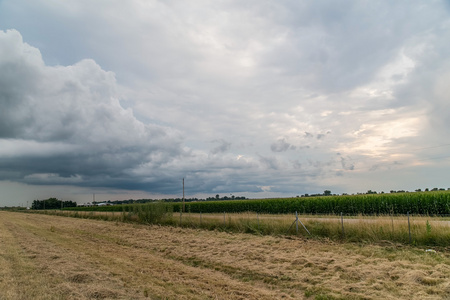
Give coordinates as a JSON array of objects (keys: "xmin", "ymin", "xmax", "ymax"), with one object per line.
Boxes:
[{"xmin": 67, "ymin": 191, "xmax": 450, "ymax": 215}]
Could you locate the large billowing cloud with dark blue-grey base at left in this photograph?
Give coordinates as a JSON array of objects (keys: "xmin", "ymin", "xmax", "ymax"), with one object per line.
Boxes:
[{"xmin": 0, "ymin": 30, "xmax": 182, "ymax": 189}]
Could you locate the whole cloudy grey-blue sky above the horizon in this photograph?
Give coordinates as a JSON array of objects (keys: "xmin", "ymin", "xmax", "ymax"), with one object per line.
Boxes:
[{"xmin": 0, "ymin": 0, "xmax": 450, "ymax": 206}]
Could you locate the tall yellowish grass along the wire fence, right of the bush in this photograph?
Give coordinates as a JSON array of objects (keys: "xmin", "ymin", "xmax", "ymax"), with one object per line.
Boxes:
[{"xmin": 174, "ymin": 213, "xmax": 450, "ymax": 247}]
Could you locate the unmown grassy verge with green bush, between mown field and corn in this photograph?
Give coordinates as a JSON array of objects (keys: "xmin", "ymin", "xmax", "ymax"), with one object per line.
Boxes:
[{"xmin": 25, "ymin": 207, "xmax": 450, "ymax": 247}]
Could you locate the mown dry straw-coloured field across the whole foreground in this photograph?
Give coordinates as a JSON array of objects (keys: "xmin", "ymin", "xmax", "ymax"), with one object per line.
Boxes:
[{"xmin": 0, "ymin": 212, "xmax": 450, "ymax": 300}]
